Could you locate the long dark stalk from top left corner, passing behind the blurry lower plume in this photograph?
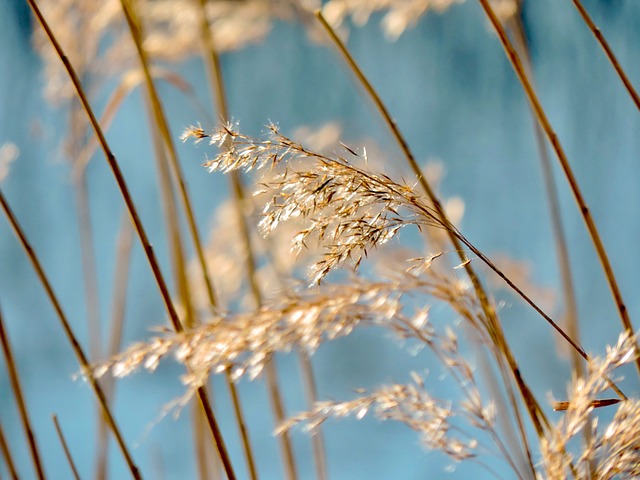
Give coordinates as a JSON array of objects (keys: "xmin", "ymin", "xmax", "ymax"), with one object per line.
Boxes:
[{"xmin": 27, "ymin": 0, "xmax": 236, "ymax": 479}]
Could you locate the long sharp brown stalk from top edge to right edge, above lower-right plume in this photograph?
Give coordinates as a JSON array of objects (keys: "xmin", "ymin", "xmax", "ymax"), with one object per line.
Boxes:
[{"xmin": 479, "ymin": 0, "xmax": 640, "ymax": 374}]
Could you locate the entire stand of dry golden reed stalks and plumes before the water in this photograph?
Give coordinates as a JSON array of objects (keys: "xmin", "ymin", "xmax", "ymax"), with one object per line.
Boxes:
[{"xmin": 0, "ymin": 0, "xmax": 640, "ymax": 479}]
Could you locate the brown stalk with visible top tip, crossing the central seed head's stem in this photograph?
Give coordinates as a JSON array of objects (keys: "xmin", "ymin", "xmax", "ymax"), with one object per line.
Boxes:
[{"xmin": 316, "ymin": 10, "xmax": 548, "ymax": 466}]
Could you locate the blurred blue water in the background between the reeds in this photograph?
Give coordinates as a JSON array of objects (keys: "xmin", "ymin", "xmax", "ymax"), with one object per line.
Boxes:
[{"xmin": 0, "ymin": 0, "xmax": 640, "ymax": 479}]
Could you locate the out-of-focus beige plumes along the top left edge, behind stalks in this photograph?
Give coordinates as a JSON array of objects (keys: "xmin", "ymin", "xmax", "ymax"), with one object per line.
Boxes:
[{"xmin": 34, "ymin": 0, "xmax": 315, "ymax": 101}]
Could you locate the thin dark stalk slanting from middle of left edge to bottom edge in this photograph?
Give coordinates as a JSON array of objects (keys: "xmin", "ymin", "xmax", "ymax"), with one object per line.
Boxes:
[{"xmin": 0, "ymin": 188, "xmax": 142, "ymax": 479}]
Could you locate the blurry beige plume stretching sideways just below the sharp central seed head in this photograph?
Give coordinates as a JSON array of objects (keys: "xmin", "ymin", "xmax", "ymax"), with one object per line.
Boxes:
[{"xmin": 95, "ymin": 281, "xmax": 408, "ymax": 388}]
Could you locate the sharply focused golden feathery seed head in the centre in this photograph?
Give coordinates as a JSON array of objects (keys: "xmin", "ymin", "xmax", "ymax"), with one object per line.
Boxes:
[{"xmin": 183, "ymin": 125, "xmax": 452, "ymax": 283}]
